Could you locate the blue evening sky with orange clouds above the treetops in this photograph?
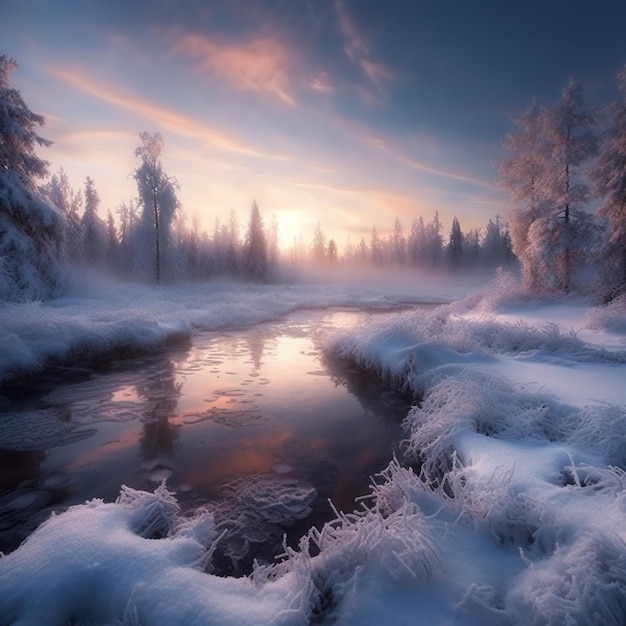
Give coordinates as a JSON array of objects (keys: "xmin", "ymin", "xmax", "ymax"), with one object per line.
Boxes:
[{"xmin": 0, "ymin": 0, "xmax": 626, "ymax": 249}]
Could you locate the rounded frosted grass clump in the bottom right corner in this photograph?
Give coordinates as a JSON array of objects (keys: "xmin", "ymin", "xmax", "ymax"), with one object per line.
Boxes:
[{"xmin": 507, "ymin": 532, "xmax": 626, "ymax": 626}]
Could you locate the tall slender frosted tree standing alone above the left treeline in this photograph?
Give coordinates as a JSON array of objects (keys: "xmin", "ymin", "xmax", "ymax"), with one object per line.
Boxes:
[{"xmin": 134, "ymin": 132, "xmax": 180, "ymax": 285}]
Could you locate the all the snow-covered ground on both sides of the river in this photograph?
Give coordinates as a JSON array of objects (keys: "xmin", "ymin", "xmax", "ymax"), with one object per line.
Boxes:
[{"xmin": 0, "ymin": 285, "xmax": 626, "ymax": 626}]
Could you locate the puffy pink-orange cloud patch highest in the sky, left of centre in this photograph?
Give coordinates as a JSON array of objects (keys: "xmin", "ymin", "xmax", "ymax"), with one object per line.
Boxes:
[{"xmin": 170, "ymin": 33, "xmax": 296, "ymax": 106}]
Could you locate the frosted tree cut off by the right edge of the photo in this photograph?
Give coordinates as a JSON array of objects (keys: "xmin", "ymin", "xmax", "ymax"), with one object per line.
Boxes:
[{"xmin": 591, "ymin": 67, "xmax": 626, "ymax": 298}]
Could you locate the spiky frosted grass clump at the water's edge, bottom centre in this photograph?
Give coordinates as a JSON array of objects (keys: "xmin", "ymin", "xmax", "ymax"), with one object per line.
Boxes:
[{"xmin": 253, "ymin": 461, "xmax": 441, "ymax": 619}]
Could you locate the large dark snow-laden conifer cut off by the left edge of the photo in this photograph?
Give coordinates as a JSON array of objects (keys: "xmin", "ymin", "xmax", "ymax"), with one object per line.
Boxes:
[{"xmin": 0, "ymin": 55, "xmax": 66, "ymax": 300}]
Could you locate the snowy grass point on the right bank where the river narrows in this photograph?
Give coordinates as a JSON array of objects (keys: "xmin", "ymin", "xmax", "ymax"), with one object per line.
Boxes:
[{"xmin": 323, "ymin": 307, "xmax": 626, "ymax": 397}]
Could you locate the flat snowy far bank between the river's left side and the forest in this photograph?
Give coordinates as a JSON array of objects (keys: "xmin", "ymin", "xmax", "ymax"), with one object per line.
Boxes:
[{"xmin": 0, "ymin": 282, "xmax": 467, "ymax": 385}]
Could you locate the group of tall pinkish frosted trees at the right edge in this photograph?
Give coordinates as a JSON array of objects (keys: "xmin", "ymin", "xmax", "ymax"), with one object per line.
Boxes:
[{"xmin": 498, "ymin": 74, "xmax": 626, "ymax": 300}]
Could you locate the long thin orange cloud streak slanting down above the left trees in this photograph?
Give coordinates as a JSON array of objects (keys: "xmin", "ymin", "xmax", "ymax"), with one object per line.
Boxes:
[{"xmin": 51, "ymin": 68, "xmax": 286, "ymax": 160}]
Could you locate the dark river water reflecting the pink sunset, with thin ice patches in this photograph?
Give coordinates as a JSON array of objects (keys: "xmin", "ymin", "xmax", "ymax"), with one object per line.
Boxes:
[{"xmin": 0, "ymin": 310, "xmax": 420, "ymax": 569}]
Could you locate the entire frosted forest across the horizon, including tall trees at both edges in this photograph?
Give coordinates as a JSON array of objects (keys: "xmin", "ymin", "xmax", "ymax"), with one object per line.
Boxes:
[{"xmin": 0, "ymin": 50, "xmax": 626, "ymax": 300}]
